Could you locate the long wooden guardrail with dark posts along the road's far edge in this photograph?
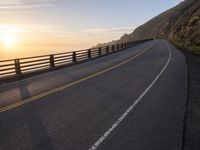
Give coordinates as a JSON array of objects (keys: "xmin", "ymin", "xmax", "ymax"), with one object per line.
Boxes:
[{"xmin": 0, "ymin": 40, "xmax": 152, "ymax": 78}]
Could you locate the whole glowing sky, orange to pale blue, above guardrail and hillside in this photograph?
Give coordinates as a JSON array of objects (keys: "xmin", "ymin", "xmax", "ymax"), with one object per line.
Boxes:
[{"xmin": 0, "ymin": 0, "xmax": 181, "ymax": 60}]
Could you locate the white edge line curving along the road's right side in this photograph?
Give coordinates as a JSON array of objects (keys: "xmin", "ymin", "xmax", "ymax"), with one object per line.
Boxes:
[{"xmin": 89, "ymin": 43, "xmax": 172, "ymax": 150}]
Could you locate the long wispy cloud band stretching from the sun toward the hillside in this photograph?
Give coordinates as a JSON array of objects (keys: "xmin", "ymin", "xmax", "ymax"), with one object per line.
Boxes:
[{"xmin": 0, "ymin": 24, "xmax": 137, "ymax": 38}]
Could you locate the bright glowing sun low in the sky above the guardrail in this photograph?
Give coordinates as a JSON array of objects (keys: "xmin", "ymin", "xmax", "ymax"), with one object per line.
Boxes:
[{"xmin": 1, "ymin": 33, "xmax": 17, "ymax": 47}]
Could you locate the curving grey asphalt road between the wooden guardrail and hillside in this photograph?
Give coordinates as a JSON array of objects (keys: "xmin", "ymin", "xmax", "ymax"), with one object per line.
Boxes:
[{"xmin": 0, "ymin": 40, "xmax": 187, "ymax": 150}]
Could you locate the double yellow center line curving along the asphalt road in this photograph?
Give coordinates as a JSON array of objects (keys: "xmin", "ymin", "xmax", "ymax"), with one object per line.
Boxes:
[{"xmin": 0, "ymin": 45, "xmax": 153, "ymax": 112}]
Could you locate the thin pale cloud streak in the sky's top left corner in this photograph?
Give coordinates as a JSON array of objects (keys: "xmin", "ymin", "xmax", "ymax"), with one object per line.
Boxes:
[{"xmin": 0, "ymin": 0, "xmax": 53, "ymax": 10}]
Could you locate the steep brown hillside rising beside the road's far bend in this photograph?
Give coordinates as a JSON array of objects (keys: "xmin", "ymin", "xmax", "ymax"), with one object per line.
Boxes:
[{"xmin": 120, "ymin": 0, "xmax": 200, "ymax": 47}]
